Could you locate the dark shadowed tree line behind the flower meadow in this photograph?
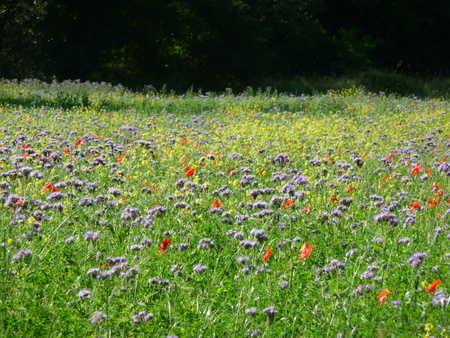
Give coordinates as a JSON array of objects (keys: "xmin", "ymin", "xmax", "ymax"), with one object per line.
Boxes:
[{"xmin": 0, "ymin": 0, "xmax": 450, "ymax": 89}]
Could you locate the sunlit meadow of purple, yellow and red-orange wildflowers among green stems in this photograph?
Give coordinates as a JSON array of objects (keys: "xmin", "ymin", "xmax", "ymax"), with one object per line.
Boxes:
[{"xmin": 0, "ymin": 81, "xmax": 450, "ymax": 338}]
